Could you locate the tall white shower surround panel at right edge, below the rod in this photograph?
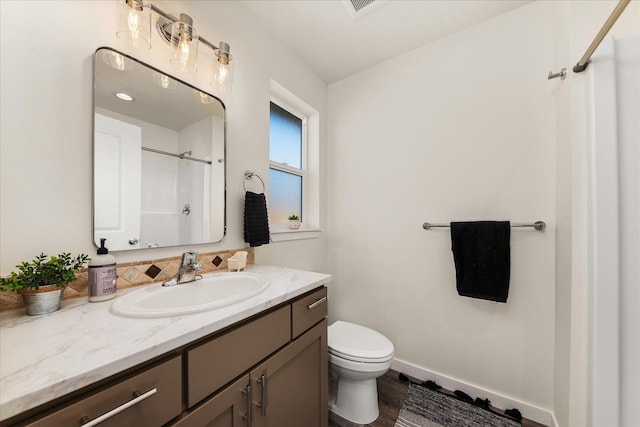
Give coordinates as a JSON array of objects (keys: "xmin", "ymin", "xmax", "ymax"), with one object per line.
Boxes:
[{"xmin": 590, "ymin": 35, "xmax": 640, "ymax": 427}]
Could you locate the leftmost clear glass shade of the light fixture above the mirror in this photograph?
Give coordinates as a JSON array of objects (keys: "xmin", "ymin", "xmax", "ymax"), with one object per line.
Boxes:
[{"xmin": 116, "ymin": 0, "xmax": 151, "ymax": 49}]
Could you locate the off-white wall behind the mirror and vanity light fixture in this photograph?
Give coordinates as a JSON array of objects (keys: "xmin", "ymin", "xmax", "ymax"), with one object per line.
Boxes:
[{"xmin": 0, "ymin": 0, "xmax": 327, "ymax": 274}]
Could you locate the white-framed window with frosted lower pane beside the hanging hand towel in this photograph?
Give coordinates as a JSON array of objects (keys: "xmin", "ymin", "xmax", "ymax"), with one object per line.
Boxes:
[{"xmin": 269, "ymin": 101, "xmax": 307, "ymax": 224}]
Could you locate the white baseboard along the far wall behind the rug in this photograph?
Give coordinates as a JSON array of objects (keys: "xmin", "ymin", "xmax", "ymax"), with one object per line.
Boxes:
[{"xmin": 391, "ymin": 359, "xmax": 557, "ymax": 427}]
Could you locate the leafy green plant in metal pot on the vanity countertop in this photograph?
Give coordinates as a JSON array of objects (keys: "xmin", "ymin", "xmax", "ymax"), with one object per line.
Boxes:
[{"xmin": 0, "ymin": 252, "xmax": 89, "ymax": 316}]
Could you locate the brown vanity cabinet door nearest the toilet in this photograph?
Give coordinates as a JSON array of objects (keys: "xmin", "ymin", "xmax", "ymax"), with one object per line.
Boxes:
[{"xmin": 251, "ymin": 319, "xmax": 328, "ymax": 427}]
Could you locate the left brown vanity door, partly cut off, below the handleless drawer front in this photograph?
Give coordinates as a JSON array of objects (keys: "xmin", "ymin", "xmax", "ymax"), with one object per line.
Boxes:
[{"xmin": 171, "ymin": 374, "xmax": 251, "ymax": 427}]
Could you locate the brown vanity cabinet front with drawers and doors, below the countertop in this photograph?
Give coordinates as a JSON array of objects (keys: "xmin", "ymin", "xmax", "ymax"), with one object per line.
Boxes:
[{"xmin": 12, "ymin": 286, "xmax": 328, "ymax": 427}]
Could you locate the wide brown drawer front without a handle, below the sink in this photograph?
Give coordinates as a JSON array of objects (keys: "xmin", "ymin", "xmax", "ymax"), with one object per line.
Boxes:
[{"xmin": 186, "ymin": 305, "xmax": 291, "ymax": 407}]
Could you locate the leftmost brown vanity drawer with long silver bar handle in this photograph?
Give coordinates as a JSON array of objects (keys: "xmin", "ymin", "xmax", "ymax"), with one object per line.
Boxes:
[{"xmin": 27, "ymin": 356, "xmax": 182, "ymax": 427}]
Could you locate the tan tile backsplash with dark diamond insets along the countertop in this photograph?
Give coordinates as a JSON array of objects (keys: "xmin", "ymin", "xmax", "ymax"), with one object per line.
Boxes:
[{"xmin": 0, "ymin": 248, "xmax": 255, "ymax": 311}]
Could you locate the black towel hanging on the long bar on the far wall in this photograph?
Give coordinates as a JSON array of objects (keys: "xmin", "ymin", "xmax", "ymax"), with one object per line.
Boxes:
[{"xmin": 451, "ymin": 221, "xmax": 511, "ymax": 302}]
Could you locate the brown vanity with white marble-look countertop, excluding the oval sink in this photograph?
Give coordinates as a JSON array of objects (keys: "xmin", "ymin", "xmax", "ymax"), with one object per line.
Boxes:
[{"xmin": 0, "ymin": 265, "xmax": 330, "ymax": 427}]
